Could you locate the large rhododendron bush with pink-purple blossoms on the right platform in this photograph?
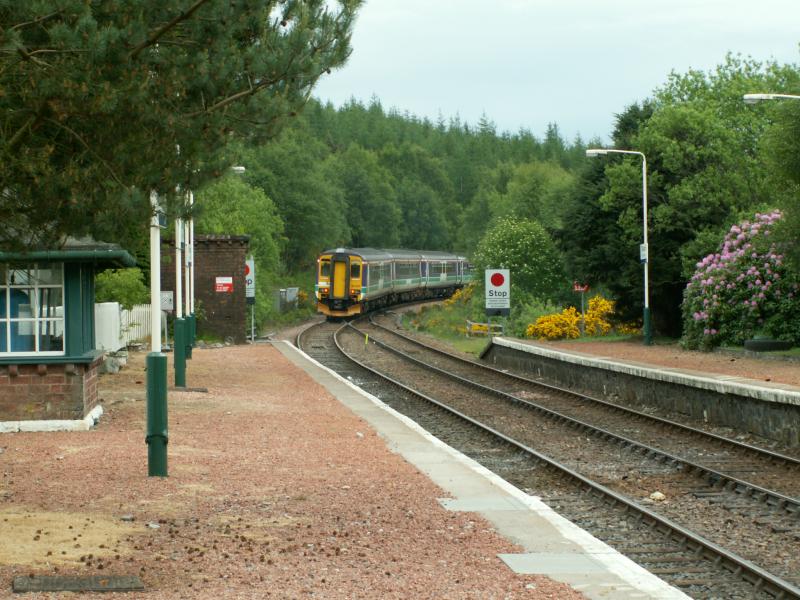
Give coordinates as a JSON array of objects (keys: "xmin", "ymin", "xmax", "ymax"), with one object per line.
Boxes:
[{"xmin": 683, "ymin": 211, "xmax": 800, "ymax": 349}]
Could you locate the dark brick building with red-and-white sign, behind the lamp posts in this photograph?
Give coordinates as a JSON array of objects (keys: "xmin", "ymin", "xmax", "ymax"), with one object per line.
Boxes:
[{"xmin": 161, "ymin": 235, "xmax": 250, "ymax": 344}]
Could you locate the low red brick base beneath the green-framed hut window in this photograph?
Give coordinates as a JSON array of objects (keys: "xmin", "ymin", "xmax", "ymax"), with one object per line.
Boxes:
[{"xmin": 0, "ymin": 359, "xmax": 101, "ymax": 421}]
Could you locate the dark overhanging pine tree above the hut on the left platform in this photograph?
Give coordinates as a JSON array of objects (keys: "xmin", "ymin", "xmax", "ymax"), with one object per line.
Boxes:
[{"xmin": 0, "ymin": 0, "xmax": 362, "ymax": 249}]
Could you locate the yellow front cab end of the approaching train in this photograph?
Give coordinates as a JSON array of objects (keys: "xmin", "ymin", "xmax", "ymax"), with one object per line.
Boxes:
[{"xmin": 316, "ymin": 253, "xmax": 363, "ymax": 317}]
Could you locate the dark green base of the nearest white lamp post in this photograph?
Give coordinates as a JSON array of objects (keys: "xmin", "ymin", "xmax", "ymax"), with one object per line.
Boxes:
[{"xmin": 145, "ymin": 352, "xmax": 169, "ymax": 477}]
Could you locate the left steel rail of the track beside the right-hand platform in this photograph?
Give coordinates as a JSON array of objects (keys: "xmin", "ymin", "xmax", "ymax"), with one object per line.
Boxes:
[{"xmin": 354, "ymin": 323, "xmax": 800, "ymax": 515}]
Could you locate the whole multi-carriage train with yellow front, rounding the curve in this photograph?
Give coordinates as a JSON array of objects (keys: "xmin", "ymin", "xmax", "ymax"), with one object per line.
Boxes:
[{"xmin": 315, "ymin": 248, "xmax": 472, "ymax": 318}]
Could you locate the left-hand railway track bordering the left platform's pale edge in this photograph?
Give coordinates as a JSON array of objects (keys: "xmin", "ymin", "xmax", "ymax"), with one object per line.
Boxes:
[{"xmin": 298, "ymin": 316, "xmax": 800, "ymax": 598}]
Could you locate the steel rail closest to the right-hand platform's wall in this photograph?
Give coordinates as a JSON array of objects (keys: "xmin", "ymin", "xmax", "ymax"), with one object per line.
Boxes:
[{"xmin": 370, "ymin": 316, "xmax": 800, "ymax": 469}]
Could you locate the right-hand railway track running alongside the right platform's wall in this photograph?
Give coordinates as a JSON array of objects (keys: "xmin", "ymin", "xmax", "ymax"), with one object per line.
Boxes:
[{"xmin": 369, "ymin": 320, "xmax": 800, "ymax": 502}]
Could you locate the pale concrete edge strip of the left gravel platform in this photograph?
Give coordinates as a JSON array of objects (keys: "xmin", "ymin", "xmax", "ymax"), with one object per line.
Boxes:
[{"xmin": 273, "ymin": 342, "xmax": 687, "ymax": 599}]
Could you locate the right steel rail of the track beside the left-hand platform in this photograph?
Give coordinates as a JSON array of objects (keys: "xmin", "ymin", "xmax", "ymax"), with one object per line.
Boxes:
[{"xmin": 326, "ymin": 323, "xmax": 800, "ymax": 600}]
